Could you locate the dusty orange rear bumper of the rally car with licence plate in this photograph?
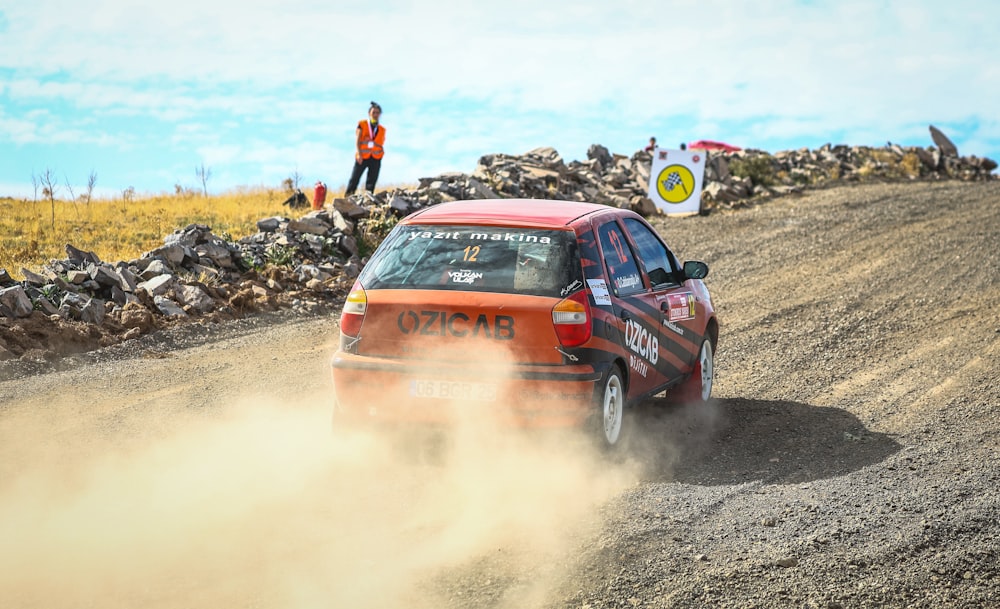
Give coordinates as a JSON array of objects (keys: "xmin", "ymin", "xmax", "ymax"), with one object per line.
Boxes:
[{"xmin": 331, "ymin": 352, "xmax": 603, "ymax": 428}]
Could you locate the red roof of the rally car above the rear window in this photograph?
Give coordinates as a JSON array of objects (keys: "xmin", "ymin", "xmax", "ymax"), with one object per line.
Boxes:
[{"xmin": 400, "ymin": 199, "xmax": 623, "ymax": 226}]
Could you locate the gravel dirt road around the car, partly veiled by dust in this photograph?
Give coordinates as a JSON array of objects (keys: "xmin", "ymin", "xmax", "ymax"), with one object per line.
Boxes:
[{"xmin": 0, "ymin": 182, "xmax": 1000, "ymax": 609}]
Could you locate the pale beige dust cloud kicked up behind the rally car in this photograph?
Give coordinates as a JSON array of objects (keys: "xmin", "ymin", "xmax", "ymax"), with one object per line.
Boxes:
[{"xmin": 0, "ymin": 384, "xmax": 636, "ymax": 609}]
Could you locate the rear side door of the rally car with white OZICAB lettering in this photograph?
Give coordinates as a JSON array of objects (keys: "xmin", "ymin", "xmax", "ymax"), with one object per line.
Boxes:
[{"xmin": 597, "ymin": 218, "xmax": 666, "ymax": 398}]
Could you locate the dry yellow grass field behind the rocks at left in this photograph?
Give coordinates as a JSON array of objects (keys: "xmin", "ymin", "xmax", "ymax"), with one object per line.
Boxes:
[{"xmin": 0, "ymin": 187, "xmax": 343, "ymax": 279}]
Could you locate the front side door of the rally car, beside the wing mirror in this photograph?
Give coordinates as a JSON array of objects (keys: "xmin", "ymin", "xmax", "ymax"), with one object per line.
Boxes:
[{"xmin": 624, "ymin": 218, "xmax": 705, "ymax": 382}]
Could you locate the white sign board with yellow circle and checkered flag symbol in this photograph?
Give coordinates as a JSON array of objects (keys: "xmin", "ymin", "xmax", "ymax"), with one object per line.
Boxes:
[{"xmin": 649, "ymin": 148, "xmax": 705, "ymax": 215}]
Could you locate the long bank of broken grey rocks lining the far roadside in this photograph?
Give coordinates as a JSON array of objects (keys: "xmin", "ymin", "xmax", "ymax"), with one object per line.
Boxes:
[{"xmin": 0, "ymin": 127, "xmax": 997, "ymax": 360}]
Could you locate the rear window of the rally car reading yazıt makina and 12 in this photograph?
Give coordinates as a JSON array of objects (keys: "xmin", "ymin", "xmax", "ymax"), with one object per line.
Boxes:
[{"xmin": 360, "ymin": 225, "xmax": 583, "ymax": 296}]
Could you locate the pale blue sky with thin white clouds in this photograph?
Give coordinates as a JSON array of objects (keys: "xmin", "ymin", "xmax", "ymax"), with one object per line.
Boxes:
[{"xmin": 0, "ymin": 0, "xmax": 1000, "ymax": 199}]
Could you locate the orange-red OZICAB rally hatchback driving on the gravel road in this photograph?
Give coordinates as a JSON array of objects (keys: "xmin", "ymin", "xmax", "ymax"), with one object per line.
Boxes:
[{"xmin": 332, "ymin": 199, "xmax": 719, "ymax": 447}]
